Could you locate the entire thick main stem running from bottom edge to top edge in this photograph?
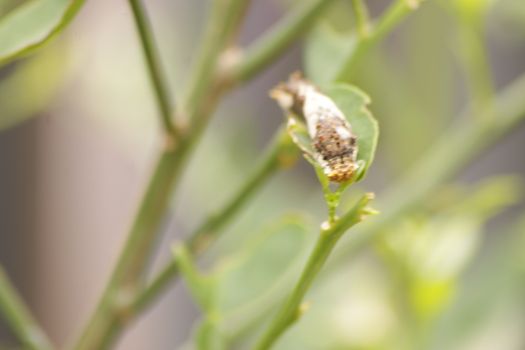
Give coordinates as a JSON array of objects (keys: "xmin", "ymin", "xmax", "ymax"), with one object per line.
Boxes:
[{"xmin": 75, "ymin": 0, "xmax": 251, "ymax": 350}]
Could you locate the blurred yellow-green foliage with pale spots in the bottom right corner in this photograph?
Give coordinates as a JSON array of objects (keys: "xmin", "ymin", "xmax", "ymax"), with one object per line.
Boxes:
[{"xmin": 264, "ymin": 176, "xmax": 524, "ymax": 350}]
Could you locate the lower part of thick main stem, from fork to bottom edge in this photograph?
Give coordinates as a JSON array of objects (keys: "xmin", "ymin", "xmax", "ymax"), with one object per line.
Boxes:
[{"xmin": 71, "ymin": 146, "xmax": 185, "ymax": 350}]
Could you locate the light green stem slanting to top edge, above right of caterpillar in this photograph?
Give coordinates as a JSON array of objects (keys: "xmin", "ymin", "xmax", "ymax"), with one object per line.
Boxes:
[{"xmin": 335, "ymin": 0, "xmax": 421, "ymax": 81}]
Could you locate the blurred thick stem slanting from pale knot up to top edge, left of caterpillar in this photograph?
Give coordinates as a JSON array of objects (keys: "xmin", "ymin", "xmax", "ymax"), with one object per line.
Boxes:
[{"xmin": 229, "ymin": 0, "xmax": 333, "ymax": 82}]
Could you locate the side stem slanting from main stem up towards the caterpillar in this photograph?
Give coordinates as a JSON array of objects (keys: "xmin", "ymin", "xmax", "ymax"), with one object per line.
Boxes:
[{"xmin": 133, "ymin": 129, "xmax": 299, "ymax": 313}]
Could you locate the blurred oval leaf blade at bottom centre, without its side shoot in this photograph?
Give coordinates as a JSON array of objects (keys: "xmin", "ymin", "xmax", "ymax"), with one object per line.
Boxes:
[{"xmin": 217, "ymin": 215, "xmax": 308, "ymax": 333}]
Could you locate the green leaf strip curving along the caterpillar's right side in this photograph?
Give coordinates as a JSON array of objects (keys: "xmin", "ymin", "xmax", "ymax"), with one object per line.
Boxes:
[{"xmin": 325, "ymin": 84, "xmax": 379, "ymax": 181}]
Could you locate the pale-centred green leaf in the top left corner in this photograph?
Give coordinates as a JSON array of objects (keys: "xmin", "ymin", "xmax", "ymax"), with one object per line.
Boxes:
[{"xmin": 0, "ymin": 0, "xmax": 84, "ymax": 64}]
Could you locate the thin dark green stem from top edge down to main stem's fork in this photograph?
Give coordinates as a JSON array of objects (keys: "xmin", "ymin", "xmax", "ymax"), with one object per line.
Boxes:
[{"xmin": 129, "ymin": 0, "xmax": 178, "ymax": 137}]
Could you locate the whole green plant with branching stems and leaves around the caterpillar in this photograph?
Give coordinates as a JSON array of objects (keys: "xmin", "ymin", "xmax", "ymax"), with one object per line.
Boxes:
[{"xmin": 0, "ymin": 0, "xmax": 525, "ymax": 350}]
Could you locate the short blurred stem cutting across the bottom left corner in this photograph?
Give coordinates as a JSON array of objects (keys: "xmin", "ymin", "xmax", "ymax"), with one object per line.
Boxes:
[{"xmin": 0, "ymin": 266, "xmax": 53, "ymax": 350}]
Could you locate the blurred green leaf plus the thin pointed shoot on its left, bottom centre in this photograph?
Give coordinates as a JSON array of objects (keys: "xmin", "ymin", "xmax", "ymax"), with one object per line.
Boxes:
[{"xmin": 174, "ymin": 216, "xmax": 308, "ymax": 349}]
